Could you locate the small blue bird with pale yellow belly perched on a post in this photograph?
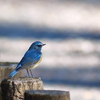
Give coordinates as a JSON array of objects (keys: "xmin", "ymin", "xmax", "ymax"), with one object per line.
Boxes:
[{"xmin": 9, "ymin": 41, "xmax": 45, "ymax": 77}]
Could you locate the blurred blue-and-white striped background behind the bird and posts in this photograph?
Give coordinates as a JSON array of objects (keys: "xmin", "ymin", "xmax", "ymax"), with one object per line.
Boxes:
[{"xmin": 0, "ymin": 0, "xmax": 100, "ymax": 100}]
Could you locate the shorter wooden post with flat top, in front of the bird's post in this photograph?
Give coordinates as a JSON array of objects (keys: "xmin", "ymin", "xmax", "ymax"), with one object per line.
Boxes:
[{"xmin": 24, "ymin": 90, "xmax": 70, "ymax": 100}]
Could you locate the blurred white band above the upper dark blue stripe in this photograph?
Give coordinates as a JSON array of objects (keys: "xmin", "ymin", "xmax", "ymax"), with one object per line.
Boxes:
[{"xmin": 0, "ymin": 0, "xmax": 100, "ymax": 31}]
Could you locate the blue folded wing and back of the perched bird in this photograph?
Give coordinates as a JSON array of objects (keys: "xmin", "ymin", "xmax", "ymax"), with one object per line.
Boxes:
[{"xmin": 16, "ymin": 51, "xmax": 41, "ymax": 70}]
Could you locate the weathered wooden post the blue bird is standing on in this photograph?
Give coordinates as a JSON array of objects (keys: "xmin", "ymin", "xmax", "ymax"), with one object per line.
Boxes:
[{"xmin": 1, "ymin": 78, "xmax": 43, "ymax": 100}]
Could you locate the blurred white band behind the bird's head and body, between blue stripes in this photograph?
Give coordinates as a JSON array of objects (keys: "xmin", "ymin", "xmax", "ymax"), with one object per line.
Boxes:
[{"xmin": 0, "ymin": 38, "xmax": 100, "ymax": 68}]
